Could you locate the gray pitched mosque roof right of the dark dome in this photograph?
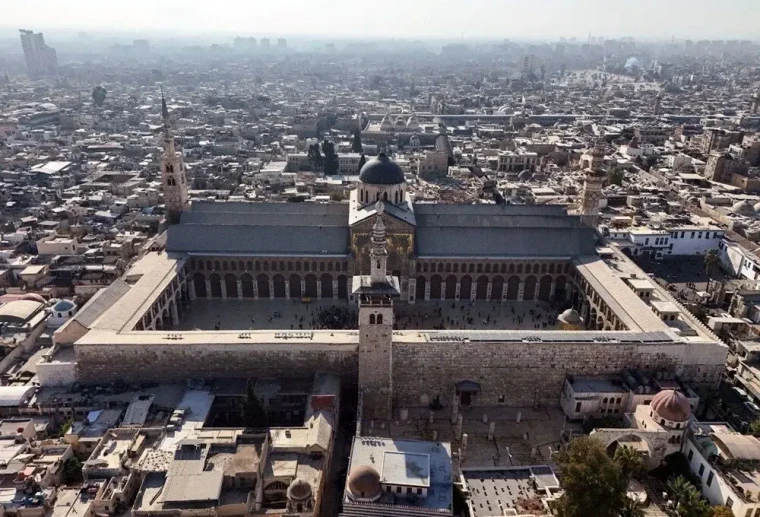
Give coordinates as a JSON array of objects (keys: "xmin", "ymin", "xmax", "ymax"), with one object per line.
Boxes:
[{"xmin": 414, "ymin": 204, "xmax": 595, "ymax": 258}]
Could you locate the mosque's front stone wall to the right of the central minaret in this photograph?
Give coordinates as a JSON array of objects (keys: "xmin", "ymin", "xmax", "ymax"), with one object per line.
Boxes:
[{"xmin": 393, "ymin": 342, "xmax": 727, "ymax": 408}]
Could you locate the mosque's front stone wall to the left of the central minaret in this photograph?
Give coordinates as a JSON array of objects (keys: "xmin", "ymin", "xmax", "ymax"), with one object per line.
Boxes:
[{"xmin": 75, "ymin": 343, "xmax": 358, "ymax": 383}]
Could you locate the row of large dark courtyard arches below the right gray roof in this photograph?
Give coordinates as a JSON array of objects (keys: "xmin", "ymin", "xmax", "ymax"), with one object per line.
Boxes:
[{"xmin": 415, "ymin": 275, "xmax": 567, "ymax": 301}]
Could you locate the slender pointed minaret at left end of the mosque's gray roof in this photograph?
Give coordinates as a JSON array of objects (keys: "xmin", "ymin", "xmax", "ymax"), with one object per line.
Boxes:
[{"xmin": 161, "ymin": 89, "xmax": 188, "ymax": 224}]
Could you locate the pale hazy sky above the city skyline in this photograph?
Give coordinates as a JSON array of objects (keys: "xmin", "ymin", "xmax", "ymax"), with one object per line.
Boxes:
[{"xmin": 0, "ymin": 0, "xmax": 760, "ymax": 39}]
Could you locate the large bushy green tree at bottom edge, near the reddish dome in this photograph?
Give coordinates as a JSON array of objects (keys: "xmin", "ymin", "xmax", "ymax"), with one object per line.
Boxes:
[{"xmin": 557, "ymin": 436, "xmax": 628, "ymax": 517}]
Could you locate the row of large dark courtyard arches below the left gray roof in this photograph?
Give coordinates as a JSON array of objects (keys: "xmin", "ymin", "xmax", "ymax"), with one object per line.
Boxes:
[{"xmin": 193, "ymin": 272, "xmax": 348, "ymax": 300}]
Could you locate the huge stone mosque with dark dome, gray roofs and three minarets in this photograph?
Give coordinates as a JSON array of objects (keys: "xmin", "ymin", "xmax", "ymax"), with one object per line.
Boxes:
[{"xmin": 58, "ymin": 100, "xmax": 727, "ymax": 419}]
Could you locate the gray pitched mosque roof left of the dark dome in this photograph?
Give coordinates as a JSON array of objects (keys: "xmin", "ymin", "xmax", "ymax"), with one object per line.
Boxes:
[{"xmin": 166, "ymin": 202, "xmax": 349, "ymax": 256}]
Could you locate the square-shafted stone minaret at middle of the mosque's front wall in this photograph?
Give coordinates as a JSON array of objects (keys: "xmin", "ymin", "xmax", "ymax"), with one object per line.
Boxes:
[{"xmin": 353, "ymin": 201, "xmax": 400, "ymax": 420}]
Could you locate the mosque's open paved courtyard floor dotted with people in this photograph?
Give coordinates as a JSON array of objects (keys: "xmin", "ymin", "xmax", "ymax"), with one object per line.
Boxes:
[{"xmin": 170, "ymin": 298, "xmax": 567, "ymax": 330}]
